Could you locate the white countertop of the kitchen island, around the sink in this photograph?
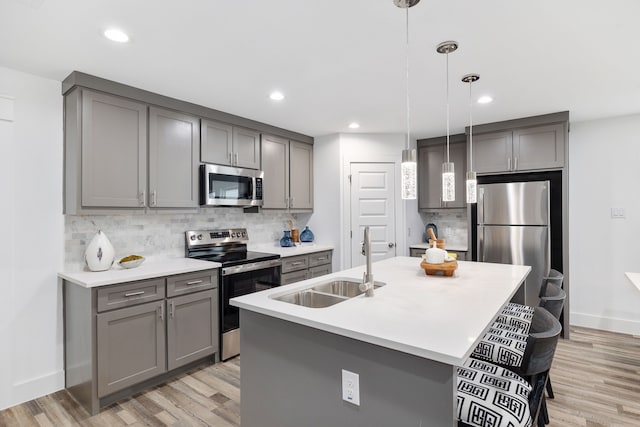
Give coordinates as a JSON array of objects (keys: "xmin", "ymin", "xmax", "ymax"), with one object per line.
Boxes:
[{"xmin": 231, "ymin": 257, "xmax": 531, "ymax": 365}]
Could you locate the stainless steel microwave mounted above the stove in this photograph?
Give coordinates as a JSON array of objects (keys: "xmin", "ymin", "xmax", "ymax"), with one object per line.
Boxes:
[{"xmin": 200, "ymin": 164, "xmax": 264, "ymax": 206}]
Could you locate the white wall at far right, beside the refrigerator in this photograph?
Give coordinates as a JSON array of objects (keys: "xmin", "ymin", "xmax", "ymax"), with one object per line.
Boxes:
[{"xmin": 569, "ymin": 115, "xmax": 640, "ymax": 334}]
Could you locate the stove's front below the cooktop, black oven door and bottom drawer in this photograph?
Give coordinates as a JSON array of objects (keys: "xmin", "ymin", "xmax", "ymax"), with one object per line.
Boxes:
[{"xmin": 220, "ymin": 259, "xmax": 280, "ymax": 360}]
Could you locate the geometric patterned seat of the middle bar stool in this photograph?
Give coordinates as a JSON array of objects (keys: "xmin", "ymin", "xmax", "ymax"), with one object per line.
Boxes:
[{"xmin": 471, "ymin": 323, "xmax": 528, "ymax": 367}]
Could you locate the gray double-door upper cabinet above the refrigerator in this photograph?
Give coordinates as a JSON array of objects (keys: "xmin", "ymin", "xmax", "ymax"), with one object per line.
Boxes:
[{"xmin": 473, "ymin": 123, "xmax": 565, "ymax": 174}]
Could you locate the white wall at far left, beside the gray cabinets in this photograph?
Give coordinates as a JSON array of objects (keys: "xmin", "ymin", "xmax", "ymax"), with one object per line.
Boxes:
[{"xmin": 0, "ymin": 67, "xmax": 64, "ymax": 409}]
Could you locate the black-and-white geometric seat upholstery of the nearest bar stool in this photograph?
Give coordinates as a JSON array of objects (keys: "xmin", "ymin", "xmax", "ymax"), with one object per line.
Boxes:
[{"xmin": 456, "ymin": 359, "xmax": 532, "ymax": 427}]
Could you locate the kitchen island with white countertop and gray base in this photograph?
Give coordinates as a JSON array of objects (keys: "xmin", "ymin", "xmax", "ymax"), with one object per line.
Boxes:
[{"xmin": 231, "ymin": 257, "xmax": 530, "ymax": 427}]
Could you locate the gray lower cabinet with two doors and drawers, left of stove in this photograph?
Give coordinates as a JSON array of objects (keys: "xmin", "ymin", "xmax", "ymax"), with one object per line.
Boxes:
[{"xmin": 63, "ymin": 270, "xmax": 219, "ymax": 414}]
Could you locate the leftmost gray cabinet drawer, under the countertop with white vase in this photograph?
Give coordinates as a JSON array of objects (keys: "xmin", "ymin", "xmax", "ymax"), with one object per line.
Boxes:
[{"xmin": 98, "ymin": 277, "xmax": 165, "ymax": 311}]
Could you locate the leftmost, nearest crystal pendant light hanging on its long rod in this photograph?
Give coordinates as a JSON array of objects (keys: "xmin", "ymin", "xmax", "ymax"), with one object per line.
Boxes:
[{"xmin": 393, "ymin": 0, "xmax": 420, "ymax": 200}]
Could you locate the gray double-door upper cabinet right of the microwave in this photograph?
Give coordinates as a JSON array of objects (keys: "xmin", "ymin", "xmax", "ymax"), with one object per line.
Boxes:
[{"xmin": 262, "ymin": 134, "xmax": 313, "ymax": 212}]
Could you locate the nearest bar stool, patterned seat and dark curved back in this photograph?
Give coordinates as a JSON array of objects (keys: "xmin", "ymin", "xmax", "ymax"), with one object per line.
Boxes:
[{"xmin": 456, "ymin": 308, "xmax": 562, "ymax": 427}]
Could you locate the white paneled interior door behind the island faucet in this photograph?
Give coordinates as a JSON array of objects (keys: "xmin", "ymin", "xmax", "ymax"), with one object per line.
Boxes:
[{"xmin": 350, "ymin": 163, "xmax": 396, "ymax": 267}]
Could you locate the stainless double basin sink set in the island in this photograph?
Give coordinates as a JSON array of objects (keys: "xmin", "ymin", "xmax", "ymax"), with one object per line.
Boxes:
[{"xmin": 272, "ymin": 278, "xmax": 384, "ymax": 308}]
